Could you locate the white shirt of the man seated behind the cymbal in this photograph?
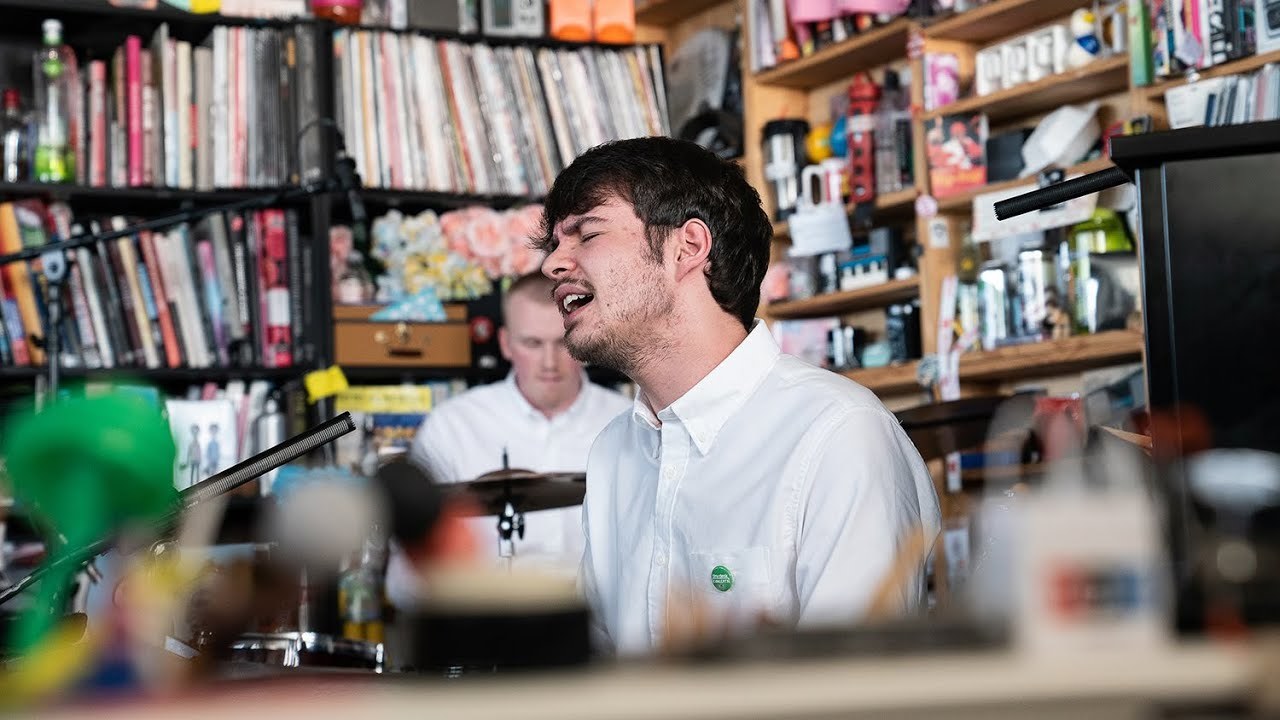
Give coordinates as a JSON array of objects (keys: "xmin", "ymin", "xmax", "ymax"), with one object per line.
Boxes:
[{"xmin": 411, "ymin": 373, "xmax": 631, "ymax": 571}]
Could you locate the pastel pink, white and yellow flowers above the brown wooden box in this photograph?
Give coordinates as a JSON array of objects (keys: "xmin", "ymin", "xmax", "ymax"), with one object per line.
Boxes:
[{"xmin": 370, "ymin": 205, "xmax": 541, "ymax": 302}]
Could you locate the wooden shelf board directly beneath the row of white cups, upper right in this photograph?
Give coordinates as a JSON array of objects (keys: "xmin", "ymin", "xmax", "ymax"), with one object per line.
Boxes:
[{"xmin": 924, "ymin": 55, "xmax": 1129, "ymax": 122}]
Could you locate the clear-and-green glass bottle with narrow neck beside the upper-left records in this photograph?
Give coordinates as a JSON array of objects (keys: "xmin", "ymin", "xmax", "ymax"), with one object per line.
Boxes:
[{"xmin": 35, "ymin": 19, "xmax": 76, "ymax": 182}]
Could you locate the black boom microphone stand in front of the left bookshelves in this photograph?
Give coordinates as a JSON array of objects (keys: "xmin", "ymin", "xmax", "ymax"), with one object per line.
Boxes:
[{"xmin": 0, "ymin": 118, "xmax": 366, "ymax": 402}]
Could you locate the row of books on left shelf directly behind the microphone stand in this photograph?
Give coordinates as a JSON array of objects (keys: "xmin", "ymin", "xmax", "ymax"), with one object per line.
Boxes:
[{"xmin": 0, "ymin": 200, "xmax": 315, "ymax": 369}]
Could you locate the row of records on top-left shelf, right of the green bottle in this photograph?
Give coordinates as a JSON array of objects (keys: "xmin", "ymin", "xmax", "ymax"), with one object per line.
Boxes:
[{"xmin": 73, "ymin": 23, "xmax": 324, "ymax": 190}]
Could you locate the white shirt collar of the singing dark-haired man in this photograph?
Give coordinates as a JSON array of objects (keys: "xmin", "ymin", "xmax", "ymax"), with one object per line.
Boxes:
[{"xmin": 632, "ymin": 319, "xmax": 781, "ymax": 455}]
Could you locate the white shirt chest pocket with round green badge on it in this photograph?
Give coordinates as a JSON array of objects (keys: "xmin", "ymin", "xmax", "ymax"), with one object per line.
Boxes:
[{"xmin": 686, "ymin": 546, "xmax": 777, "ymax": 630}]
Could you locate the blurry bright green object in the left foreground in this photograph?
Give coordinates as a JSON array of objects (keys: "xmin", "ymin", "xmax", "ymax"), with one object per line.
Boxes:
[{"xmin": 3, "ymin": 392, "xmax": 178, "ymax": 647}]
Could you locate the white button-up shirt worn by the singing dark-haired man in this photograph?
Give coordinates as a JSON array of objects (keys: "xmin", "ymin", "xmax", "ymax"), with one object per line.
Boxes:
[{"xmin": 581, "ymin": 320, "xmax": 940, "ymax": 655}]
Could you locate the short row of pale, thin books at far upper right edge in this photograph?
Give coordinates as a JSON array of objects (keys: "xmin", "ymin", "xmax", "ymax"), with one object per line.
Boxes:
[{"xmin": 1165, "ymin": 63, "xmax": 1280, "ymax": 129}]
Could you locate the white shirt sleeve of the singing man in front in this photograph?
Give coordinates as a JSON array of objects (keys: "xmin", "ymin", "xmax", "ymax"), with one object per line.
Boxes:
[{"xmin": 795, "ymin": 409, "xmax": 938, "ymax": 626}]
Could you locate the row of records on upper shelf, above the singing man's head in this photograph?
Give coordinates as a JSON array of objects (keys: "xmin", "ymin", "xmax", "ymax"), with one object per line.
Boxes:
[{"xmin": 334, "ymin": 29, "xmax": 669, "ymax": 195}]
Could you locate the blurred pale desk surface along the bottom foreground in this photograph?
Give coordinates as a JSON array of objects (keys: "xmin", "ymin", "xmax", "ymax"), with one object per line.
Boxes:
[{"xmin": 32, "ymin": 644, "xmax": 1262, "ymax": 720}]
